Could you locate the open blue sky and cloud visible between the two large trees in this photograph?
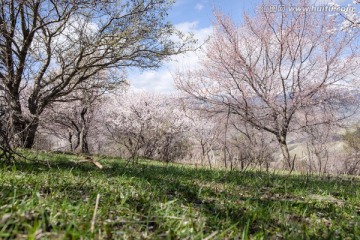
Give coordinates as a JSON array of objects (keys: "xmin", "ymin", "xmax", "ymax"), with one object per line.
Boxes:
[{"xmin": 128, "ymin": 0, "xmax": 359, "ymax": 94}]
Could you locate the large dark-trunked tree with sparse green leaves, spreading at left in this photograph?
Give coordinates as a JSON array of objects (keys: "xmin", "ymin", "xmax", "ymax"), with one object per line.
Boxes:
[{"xmin": 0, "ymin": 0, "xmax": 193, "ymax": 148}]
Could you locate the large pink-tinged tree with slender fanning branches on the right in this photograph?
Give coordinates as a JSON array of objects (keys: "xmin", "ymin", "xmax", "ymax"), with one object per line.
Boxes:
[{"xmin": 176, "ymin": 0, "xmax": 357, "ymax": 169}]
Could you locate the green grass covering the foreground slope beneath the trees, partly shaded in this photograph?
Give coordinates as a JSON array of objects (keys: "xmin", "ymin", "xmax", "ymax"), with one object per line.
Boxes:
[{"xmin": 0, "ymin": 152, "xmax": 360, "ymax": 239}]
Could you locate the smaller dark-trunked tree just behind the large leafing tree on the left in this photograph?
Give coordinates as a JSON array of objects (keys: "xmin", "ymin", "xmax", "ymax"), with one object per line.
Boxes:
[{"xmin": 40, "ymin": 70, "xmax": 128, "ymax": 154}]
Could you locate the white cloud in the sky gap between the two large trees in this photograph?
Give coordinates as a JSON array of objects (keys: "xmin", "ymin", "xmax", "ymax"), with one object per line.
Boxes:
[{"xmin": 129, "ymin": 21, "xmax": 212, "ymax": 93}]
